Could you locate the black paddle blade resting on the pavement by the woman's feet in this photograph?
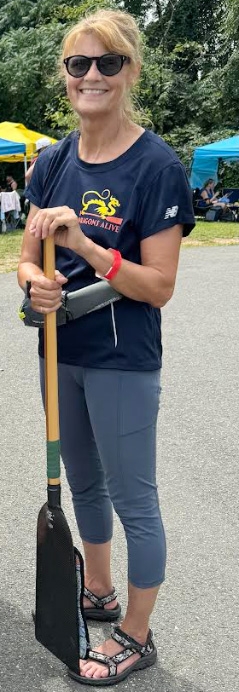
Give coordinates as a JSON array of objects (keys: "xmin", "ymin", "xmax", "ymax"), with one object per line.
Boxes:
[{"xmin": 35, "ymin": 503, "xmax": 79, "ymax": 672}]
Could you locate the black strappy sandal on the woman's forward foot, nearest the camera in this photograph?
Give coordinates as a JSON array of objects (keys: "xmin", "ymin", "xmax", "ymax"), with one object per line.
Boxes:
[{"xmin": 68, "ymin": 627, "xmax": 157, "ymax": 687}]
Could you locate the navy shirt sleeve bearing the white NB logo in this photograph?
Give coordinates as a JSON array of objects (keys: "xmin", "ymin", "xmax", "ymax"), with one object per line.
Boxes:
[{"xmin": 137, "ymin": 162, "xmax": 195, "ymax": 239}]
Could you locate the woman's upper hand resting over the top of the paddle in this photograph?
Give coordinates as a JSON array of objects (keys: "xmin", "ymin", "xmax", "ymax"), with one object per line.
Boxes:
[{"xmin": 29, "ymin": 207, "xmax": 87, "ymax": 255}]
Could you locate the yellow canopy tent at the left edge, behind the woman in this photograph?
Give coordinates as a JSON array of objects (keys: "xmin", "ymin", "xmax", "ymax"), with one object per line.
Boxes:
[{"xmin": 0, "ymin": 121, "xmax": 57, "ymax": 163}]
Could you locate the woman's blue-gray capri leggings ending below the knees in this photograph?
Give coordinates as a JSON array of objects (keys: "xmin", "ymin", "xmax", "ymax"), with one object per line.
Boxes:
[{"xmin": 40, "ymin": 358, "xmax": 166, "ymax": 589}]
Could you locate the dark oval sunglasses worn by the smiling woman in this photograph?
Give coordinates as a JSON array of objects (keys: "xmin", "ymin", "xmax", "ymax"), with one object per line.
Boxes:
[{"xmin": 63, "ymin": 53, "xmax": 130, "ymax": 78}]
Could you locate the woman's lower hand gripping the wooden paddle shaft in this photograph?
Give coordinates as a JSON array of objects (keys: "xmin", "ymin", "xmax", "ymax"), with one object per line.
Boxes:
[{"xmin": 30, "ymin": 270, "xmax": 68, "ymax": 315}]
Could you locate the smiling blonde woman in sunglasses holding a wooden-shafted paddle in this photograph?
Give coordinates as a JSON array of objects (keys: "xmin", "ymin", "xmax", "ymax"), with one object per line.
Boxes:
[{"xmin": 19, "ymin": 10, "xmax": 194, "ymax": 685}]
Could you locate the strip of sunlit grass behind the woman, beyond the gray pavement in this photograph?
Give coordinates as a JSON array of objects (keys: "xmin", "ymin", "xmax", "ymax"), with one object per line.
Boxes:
[{"xmin": 0, "ymin": 221, "xmax": 239, "ymax": 273}]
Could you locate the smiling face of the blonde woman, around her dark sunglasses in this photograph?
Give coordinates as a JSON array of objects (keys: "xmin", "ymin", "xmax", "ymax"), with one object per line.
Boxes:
[{"xmin": 66, "ymin": 34, "xmax": 132, "ymax": 118}]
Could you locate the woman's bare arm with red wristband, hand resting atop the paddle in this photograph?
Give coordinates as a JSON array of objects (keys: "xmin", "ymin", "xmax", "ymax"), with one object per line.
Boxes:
[{"xmin": 29, "ymin": 207, "xmax": 182, "ymax": 308}]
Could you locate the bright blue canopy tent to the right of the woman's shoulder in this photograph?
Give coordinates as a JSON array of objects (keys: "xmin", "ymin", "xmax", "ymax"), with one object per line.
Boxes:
[{"xmin": 190, "ymin": 135, "xmax": 239, "ymax": 189}]
